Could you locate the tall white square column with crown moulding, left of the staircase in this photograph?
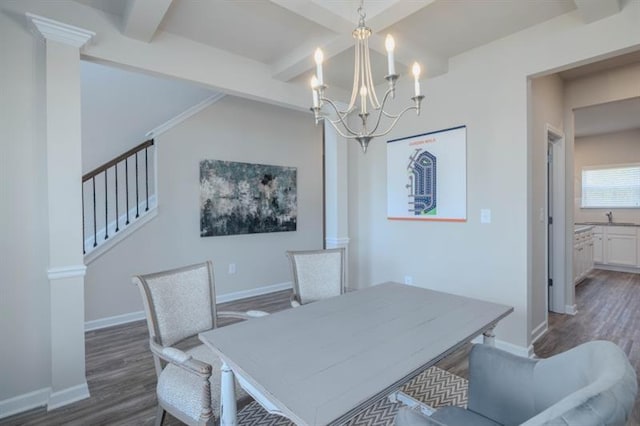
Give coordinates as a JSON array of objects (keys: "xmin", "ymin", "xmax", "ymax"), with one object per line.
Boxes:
[{"xmin": 27, "ymin": 13, "xmax": 95, "ymax": 409}]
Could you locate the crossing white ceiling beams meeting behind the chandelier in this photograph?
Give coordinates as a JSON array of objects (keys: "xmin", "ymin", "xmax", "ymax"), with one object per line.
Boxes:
[{"xmin": 271, "ymin": 0, "xmax": 448, "ymax": 81}]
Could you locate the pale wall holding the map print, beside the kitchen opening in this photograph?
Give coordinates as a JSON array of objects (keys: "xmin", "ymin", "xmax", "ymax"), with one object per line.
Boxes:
[{"xmin": 349, "ymin": 2, "xmax": 640, "ymax": 351}]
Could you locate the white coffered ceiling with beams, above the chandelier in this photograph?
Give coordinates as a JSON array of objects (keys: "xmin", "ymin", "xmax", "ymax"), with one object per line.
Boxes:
[{"xmin": 76, "ymin": 0, "xmax": 620, "ymax": 90}]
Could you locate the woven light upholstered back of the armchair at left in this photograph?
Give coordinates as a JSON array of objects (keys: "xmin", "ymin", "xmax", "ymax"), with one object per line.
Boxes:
[{"xmin": 133, "ymin": 261, "xmax": 216, "ymax": 352}]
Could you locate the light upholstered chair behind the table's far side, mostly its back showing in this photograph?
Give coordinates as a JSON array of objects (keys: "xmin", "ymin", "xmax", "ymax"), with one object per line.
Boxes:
[{"xmin": 287, "ymin": 248, "xmax": 346, "ymax": 307}]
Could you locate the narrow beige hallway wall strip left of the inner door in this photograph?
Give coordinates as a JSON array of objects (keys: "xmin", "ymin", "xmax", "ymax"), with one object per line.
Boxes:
[{"xmin": 529, "ymin": 74, "xmax": 563, "ymax": 338}]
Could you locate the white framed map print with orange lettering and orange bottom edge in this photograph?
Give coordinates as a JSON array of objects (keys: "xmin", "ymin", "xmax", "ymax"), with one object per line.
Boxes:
[{"xmin": 387, "ymin": 126, "xmax": 467, "ymax": 222}]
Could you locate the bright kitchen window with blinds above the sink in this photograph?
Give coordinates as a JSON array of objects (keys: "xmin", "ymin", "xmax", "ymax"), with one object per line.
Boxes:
[{"xmin": 582, "ymin": 164, "xmax": 640, "ymax": 208}]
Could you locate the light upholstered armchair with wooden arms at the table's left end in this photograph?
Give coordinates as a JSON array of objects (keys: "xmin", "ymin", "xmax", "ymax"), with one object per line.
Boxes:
[{"xmin": 133, "ymin": 262, "xmax": 266, "ymax": 425}]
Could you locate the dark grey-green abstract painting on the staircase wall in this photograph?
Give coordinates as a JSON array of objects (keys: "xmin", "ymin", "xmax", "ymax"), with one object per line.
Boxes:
[{"xmin": 200, "ymin": 160, "xmax": 298, "ymax": 237}]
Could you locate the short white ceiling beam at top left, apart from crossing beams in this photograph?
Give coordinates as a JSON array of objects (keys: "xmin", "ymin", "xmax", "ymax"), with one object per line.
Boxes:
[{"xmin": 122, "ymin": 0, "xmax": 172, "ymax": 43}]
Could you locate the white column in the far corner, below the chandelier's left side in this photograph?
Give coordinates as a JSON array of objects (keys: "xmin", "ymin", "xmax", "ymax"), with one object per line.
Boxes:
[{"xmin": 324, "ymin": 121, "xmax": 349, "ymax": 288}]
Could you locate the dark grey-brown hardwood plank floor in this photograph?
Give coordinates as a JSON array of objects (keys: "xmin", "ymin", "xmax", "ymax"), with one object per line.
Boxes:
[{"xmin": 0, "ymin": 271, "xmax": 640, "ymax": 426}]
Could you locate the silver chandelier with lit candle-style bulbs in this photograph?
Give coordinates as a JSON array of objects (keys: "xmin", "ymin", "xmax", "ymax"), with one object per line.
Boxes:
[{"xmin": 311, "ymin": 0, "xmax": 424, "ymax": 153}]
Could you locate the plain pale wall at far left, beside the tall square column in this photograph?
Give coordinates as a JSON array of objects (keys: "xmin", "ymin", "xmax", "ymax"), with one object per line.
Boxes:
[{"xmin": 0, "ymin": 6, "xmax": 51, "ymax": 402}]
